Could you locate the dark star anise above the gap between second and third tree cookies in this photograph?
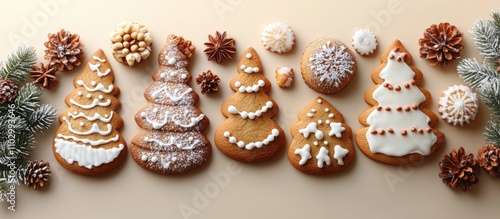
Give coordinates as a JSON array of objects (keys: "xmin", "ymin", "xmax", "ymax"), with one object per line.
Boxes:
[{"xmin": 203, "ymin": 31, "xmax": 236, "ymax": 64}]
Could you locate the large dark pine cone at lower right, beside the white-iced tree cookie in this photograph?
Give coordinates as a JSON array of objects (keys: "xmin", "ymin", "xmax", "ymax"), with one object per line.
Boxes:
[{"xmin": 439, "ymin": 147, "xmax": 479, "ymax": 191}]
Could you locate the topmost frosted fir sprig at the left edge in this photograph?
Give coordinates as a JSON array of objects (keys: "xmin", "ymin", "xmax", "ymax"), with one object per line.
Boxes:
[{"xmin": 0, "ymin": 46, "xmax": 36, "ymax": 84}]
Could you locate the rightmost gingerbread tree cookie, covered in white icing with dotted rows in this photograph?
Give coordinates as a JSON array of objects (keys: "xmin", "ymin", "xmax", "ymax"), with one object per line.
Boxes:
[{"xmin": 356, "ymin": 40, "xmax": 445, "ymax": 165}]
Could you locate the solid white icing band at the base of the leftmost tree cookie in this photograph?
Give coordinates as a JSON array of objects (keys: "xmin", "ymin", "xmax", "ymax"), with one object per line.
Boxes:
[{"xmin": 54, "ymin": 138, "xmax": 125, "ymax": 169}]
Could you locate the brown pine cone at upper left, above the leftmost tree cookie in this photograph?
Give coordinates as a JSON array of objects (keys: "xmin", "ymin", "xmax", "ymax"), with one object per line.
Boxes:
[{"xmin": 44, "ymin": 29, "xmax": 84, "ymax": 72}]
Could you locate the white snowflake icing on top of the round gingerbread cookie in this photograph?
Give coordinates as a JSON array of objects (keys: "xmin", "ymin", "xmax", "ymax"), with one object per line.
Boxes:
[{"xmin": 308, "ymin": 41, "xmax": 356, "ymax": 87}]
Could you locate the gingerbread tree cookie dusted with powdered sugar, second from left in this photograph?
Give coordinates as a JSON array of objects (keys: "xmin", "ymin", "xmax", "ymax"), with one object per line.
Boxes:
[{"xmin": 130, "ymin": 35, "xmax": 212, "ymax": 174}]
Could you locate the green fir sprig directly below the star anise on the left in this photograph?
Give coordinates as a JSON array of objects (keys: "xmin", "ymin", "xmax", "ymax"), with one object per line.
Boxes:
[{"xmin": 14, "ymin": 83, "xmax": 43, "ymax": 118}]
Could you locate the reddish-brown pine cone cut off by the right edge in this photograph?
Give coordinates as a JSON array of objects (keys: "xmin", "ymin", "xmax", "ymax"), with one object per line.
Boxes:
[{"xmin": 477, "ymin": 145, "xmax": 500, "ymax": 177}]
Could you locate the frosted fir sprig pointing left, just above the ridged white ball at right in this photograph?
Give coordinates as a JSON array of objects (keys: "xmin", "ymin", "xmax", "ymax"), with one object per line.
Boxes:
[{"xmin": 457, "ymin": 59, "xmax": 500, "ymax": 88}]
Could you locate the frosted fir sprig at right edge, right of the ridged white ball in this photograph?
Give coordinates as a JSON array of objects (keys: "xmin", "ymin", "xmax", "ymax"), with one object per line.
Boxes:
[{"xmin": 479, "ymin": 80, "xmax": 500, "ymax": 119}]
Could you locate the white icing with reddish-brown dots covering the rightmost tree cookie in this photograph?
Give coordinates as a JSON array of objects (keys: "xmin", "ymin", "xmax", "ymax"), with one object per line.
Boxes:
[{"xmin": 366, "ymin": 50, "xmax": 437, "ymax": 156}]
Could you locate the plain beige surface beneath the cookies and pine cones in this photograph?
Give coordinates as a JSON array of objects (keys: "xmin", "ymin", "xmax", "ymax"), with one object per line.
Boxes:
[{"xmin": 0, "ymin": 0, "xmax": 500, "ymax": 218}]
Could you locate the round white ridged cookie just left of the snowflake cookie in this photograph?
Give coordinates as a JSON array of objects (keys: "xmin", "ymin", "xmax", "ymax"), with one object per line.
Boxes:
[{"xmin": 260, "ymin": 21, "xmax": 295, "ymax": 53}]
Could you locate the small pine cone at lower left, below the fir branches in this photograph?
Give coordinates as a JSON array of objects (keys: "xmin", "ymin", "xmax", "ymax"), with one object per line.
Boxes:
[{"xmin": 26, "ymin": 160, "xmax": 52, "ymax": 190}]
